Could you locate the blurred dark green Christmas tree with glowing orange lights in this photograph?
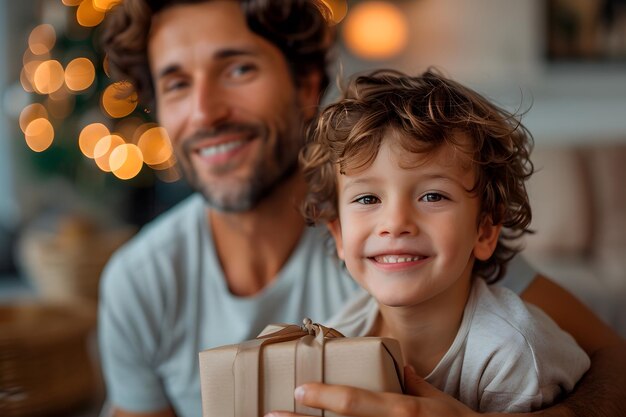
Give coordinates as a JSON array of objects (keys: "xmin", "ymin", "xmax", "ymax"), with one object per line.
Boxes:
[{"xmin": 19, "ymin": 0, "xmax": 188, "ymax": 228}]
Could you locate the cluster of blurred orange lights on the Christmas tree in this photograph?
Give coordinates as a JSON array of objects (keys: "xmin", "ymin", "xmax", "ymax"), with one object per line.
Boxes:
[{"xmin": 19, "ymin": 0, "xmax": 179, "ymax": 182}]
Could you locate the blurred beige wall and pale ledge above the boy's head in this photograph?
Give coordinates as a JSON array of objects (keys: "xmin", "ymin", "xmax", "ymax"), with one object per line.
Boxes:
[{"xmin": 341, "ymin": 0, "xmax": 626, "ymax": 144}]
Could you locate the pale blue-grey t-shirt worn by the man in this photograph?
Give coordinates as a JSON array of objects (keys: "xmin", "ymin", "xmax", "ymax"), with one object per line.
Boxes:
[{"xmin": 99, "ymin": 195, "xmax": 535, "ymax": 417}]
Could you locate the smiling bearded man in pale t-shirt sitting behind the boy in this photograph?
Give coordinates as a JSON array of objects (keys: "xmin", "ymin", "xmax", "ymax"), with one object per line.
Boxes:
[{"xmin": 100, "ymin": 0, "xmax": 626, "ymax": 417}]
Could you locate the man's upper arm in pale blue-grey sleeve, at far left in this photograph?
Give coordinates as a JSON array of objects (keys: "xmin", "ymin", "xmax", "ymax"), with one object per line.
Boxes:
[{"xmin": 98, "ymin": 252, "xmax": 176, "ymax": 417}]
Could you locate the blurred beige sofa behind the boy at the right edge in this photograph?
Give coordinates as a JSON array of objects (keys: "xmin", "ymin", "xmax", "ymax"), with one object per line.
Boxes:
[{"xmin": 523, "ymin": 141, "xmax": 626, "ymax": 337}]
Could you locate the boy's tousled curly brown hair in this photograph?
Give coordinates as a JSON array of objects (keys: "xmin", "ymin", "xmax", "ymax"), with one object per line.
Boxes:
[{"xmin": 300, "ymin": 69, "xmax": 534, "ymax": 283}]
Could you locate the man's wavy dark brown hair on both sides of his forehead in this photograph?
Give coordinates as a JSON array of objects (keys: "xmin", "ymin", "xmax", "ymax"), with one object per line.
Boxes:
[{"xmin": 100, "ymin": 0, "xmax": 335, "ymax": 106}]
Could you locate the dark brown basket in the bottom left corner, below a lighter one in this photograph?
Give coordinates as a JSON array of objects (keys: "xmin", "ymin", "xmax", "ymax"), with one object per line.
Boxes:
[{"xmin": 0, "ymin": 302, "xmax": 97, "ymax": 417}]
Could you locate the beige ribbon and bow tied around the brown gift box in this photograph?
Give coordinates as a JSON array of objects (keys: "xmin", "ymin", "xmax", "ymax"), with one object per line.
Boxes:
[{"xmin": 233, "ymin": 318, "xmax": 343, "ymax": 417}]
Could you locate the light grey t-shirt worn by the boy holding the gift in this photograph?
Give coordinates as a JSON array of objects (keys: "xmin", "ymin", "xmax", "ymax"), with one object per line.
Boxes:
[{"xmin": 328, "ymin": 279, "xmax": 590, "ymax": 413}]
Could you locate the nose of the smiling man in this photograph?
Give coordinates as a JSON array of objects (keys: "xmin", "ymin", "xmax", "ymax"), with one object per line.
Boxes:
[{"xmin": 191, "ymin": 80, "xmax": 230, "ymax": 128}]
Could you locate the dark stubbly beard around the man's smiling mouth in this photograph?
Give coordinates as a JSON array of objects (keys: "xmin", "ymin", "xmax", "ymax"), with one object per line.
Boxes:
[{"xmin": 181, "ymin": 119, "xmax": 302, "ymax": 213}]
